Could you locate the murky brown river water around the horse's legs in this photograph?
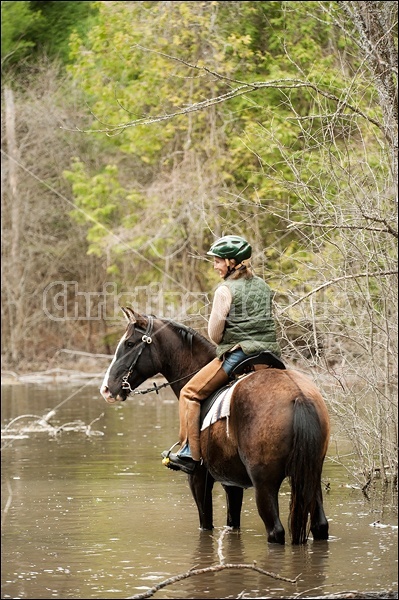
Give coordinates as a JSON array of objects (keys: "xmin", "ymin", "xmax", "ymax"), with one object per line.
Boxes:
[{"xmin": 1, "ymin": 379, "xmax": 398, "ymax": 600}]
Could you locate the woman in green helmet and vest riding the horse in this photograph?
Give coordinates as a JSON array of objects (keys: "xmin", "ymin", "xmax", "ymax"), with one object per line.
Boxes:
[{"xmin": 162, "ymin": 235, "xmax": 280, "ymax": 473}]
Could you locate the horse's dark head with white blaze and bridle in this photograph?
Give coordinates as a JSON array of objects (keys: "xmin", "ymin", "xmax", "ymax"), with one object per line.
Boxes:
[{"xmin": 100, "ymin": 308, "xmax": 159, "ymax": 404}]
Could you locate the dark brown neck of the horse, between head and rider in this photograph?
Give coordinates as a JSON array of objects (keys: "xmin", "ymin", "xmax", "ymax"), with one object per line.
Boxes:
[{"xmin": 161, "ymin": 328, "xmax": 215, "ymax": 397}]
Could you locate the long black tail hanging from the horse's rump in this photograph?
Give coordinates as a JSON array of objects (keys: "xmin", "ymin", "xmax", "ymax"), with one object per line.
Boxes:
[{"xmin": 286, "ymin": 396, "xmax": 324, "ymax": 544}]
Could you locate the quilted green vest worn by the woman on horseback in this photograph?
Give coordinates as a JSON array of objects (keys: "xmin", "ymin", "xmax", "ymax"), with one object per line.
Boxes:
[{"xmin": 216, "ymin": 276, "xmax": 281, "ymax": 358}]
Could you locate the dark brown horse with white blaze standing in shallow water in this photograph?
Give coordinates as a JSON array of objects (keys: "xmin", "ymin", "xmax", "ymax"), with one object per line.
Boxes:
[{"xmin": 101, "ymin": 309, "xmax": 329, "ymax": 544}]
